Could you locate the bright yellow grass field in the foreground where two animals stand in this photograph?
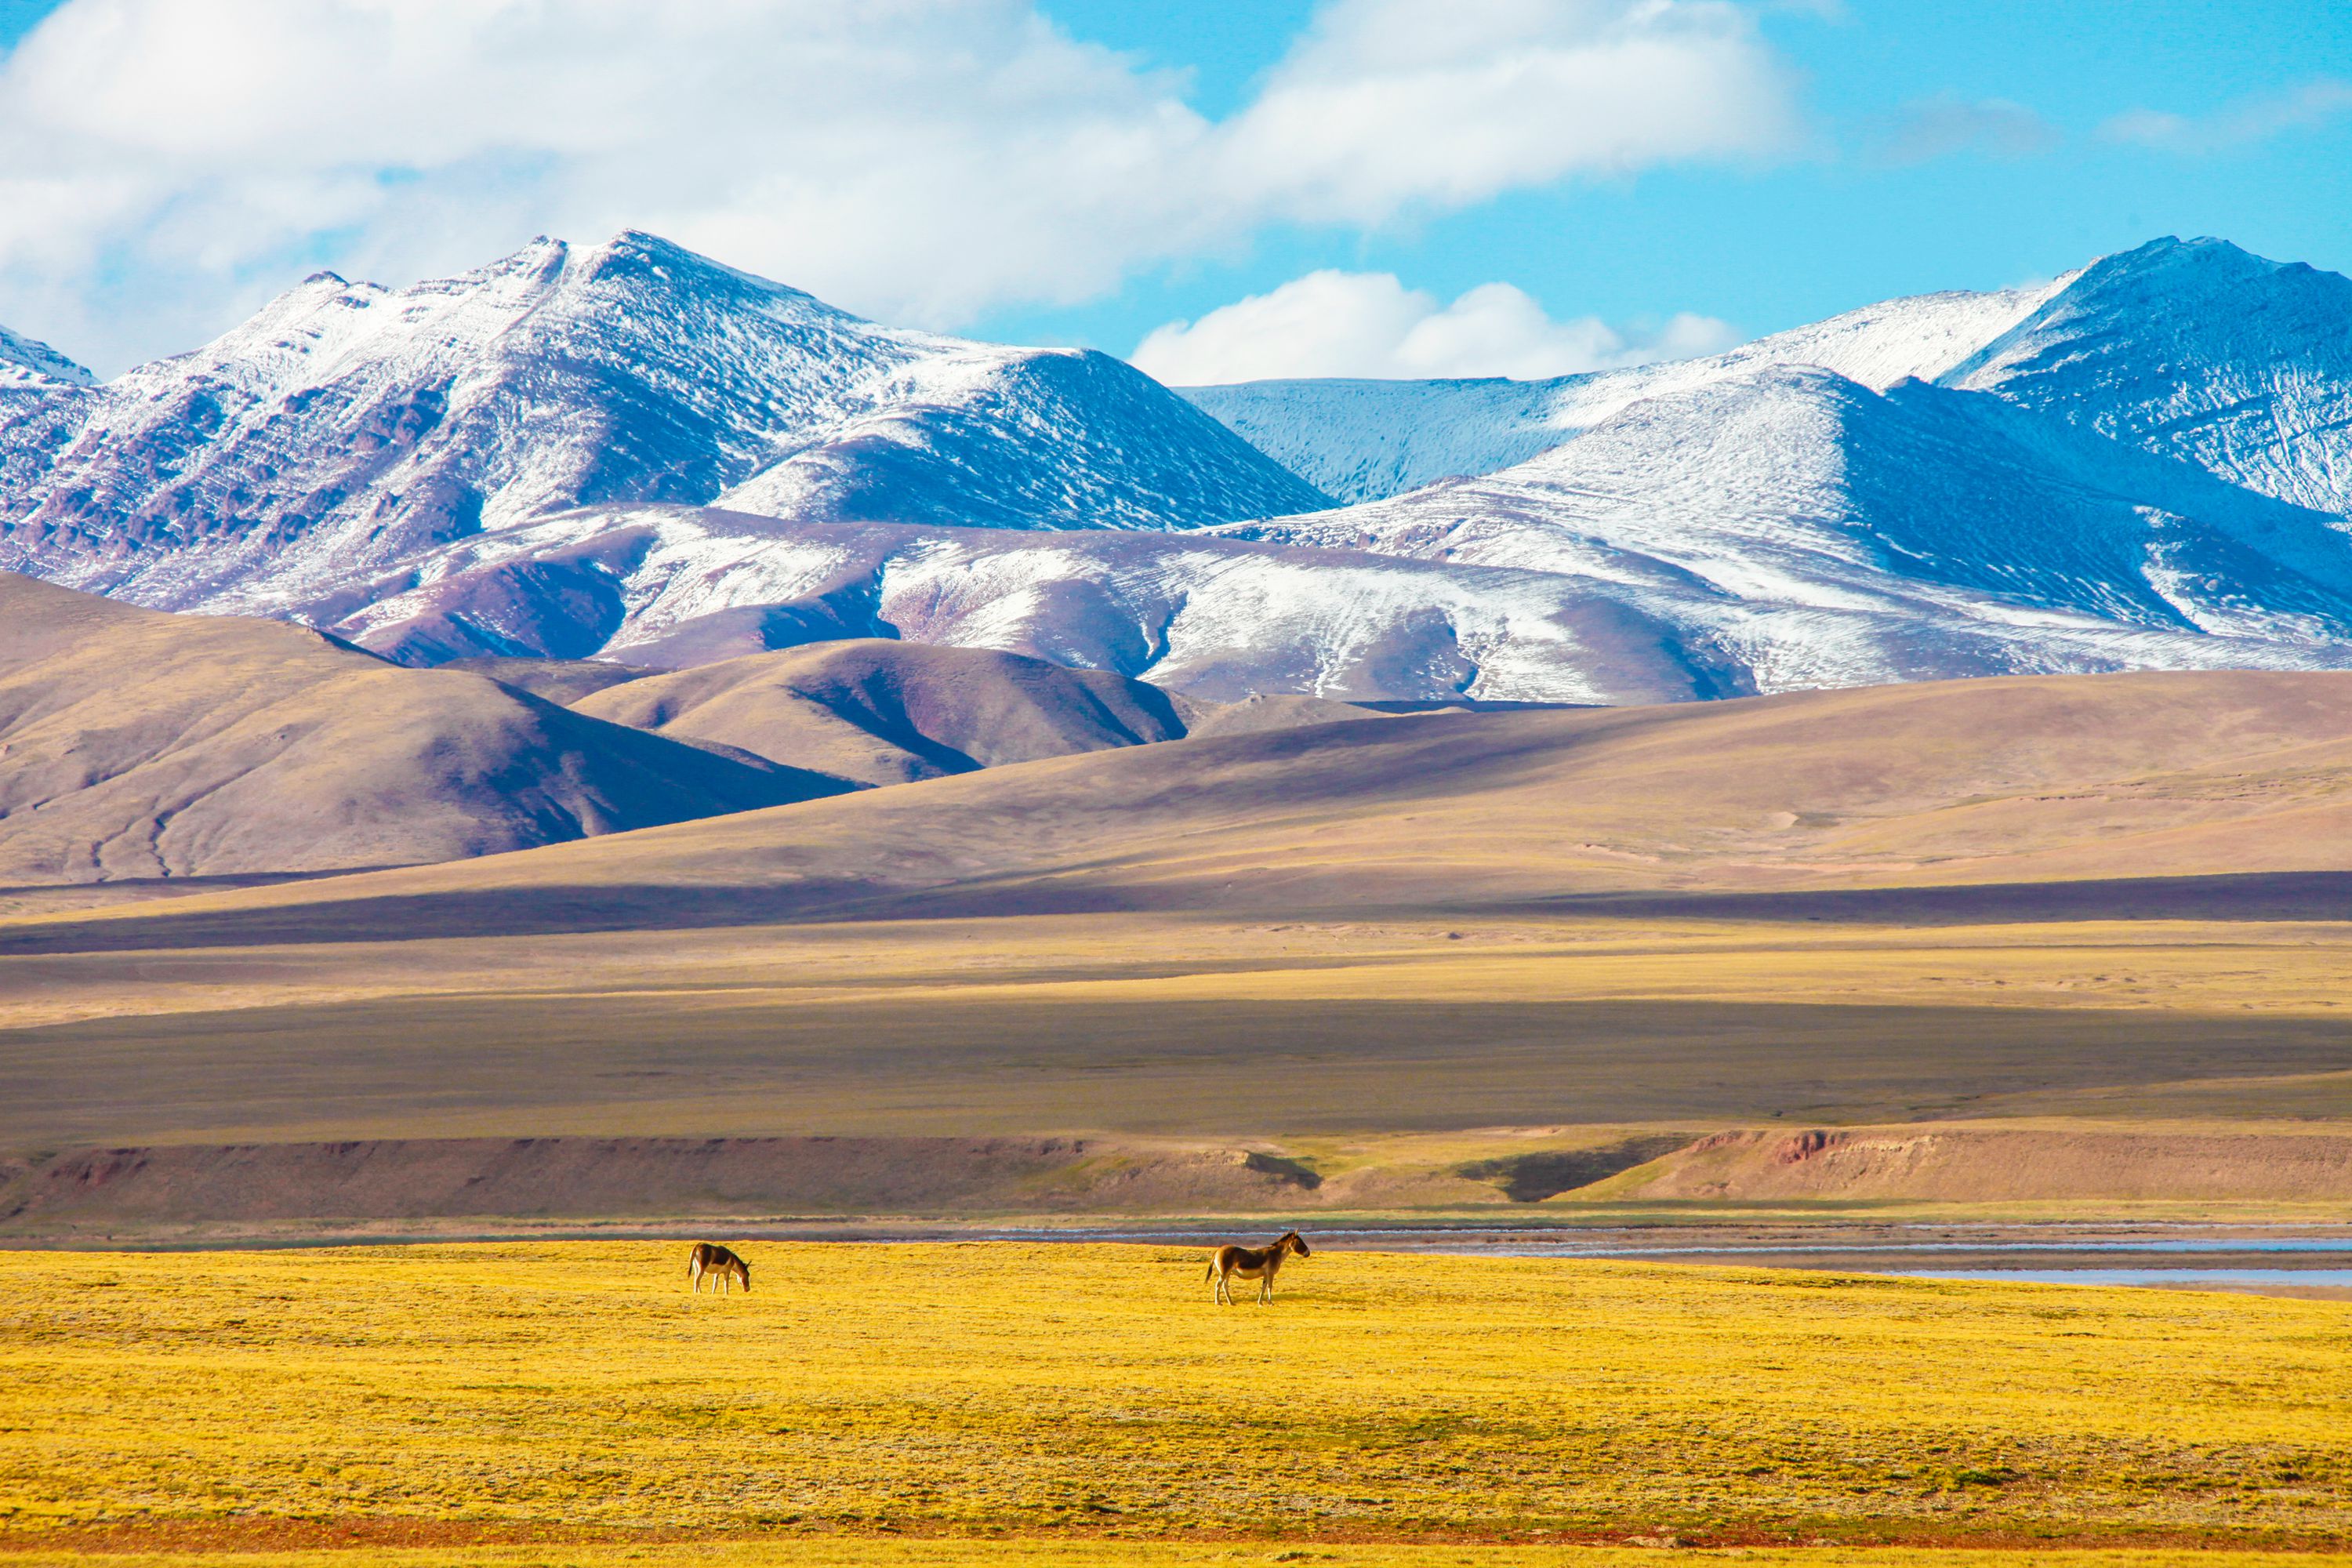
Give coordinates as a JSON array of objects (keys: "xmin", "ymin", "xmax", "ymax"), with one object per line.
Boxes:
[{"xmin": 0, "ymin": 1243, "xmax": 2352, "ymax": 1568}]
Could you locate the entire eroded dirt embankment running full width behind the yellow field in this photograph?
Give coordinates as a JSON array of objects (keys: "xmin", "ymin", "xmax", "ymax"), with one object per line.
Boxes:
[{"xmin": 0, "ymin": 1123, "xmax": 2352, "ymax": 1236}]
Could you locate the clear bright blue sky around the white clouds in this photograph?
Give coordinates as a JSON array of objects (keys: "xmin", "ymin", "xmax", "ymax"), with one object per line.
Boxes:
[{"xmin": 993, "ymin": 0, "xmax": 2352, "ymax": 357}]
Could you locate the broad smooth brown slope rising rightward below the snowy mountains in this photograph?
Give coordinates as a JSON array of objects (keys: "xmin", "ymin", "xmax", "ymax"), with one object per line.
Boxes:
[{"xmin": 32, "ymin": 673, "xmax": 2352, "ymax": 940}]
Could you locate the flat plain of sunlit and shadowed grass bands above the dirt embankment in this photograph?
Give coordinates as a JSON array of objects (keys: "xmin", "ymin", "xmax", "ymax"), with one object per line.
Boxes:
[{"xmin": 0, "ymin": 907, "xmax": 2352, "ymax": 1152}]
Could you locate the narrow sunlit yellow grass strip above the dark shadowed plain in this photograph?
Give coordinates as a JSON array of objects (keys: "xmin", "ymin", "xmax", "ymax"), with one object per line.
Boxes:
[{"xmin": 13, "ymin": 914, "xmax": 2352, "ymax": 1044}]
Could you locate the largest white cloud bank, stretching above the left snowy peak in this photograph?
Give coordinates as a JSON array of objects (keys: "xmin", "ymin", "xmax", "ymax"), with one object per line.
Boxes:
[{"xmin": 0, "ymin": 0, "xmax": 1797, "ymax": 367}]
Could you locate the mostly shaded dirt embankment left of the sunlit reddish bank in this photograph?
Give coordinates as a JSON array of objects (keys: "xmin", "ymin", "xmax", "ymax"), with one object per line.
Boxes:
[{"xmin": 0, "ymin": 1133, "xmax": 1689, "ymax": 1234}]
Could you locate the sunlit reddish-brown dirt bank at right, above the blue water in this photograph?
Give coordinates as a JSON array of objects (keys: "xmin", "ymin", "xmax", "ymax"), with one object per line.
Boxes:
[{"xmin": 1576, "ymin": 1126, "xmax": 2352, "ymax": 1203}]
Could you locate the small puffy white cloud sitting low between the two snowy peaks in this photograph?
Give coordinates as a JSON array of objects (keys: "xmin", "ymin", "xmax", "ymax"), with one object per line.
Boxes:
[{"xmin": 1129, "ymin": 270, "xmax": 1733, "ymax": 386}]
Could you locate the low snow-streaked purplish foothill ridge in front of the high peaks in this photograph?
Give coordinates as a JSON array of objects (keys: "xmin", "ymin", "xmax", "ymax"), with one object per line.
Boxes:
[{"xmin": 318, "ymin": 508, "xmax": 1740, "ymax": 703}]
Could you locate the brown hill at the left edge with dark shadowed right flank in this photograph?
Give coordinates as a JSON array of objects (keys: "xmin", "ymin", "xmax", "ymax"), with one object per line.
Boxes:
[{"xmin": 0, "ymin": 576, "xmax": 847, "ymax": 884}]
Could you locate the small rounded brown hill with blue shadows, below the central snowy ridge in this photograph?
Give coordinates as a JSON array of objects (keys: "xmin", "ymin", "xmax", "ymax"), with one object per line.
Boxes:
[{"xmin": 574, "ymin": 637, "xmax": 1185, "ymax": 785}]
